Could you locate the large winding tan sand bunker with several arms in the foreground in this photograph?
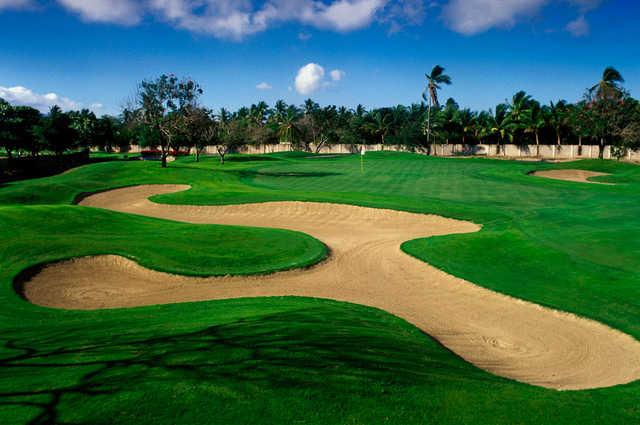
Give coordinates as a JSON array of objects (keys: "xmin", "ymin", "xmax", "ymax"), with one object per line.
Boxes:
[{"xmin": 21, "ymin": 185, "xmax": 640, "ymax": 389}]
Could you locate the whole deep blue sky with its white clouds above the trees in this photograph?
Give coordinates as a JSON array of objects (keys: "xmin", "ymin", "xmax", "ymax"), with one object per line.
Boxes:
[{"xmin": 0, "ymin": 0, "xmax": 640, "ymax": 113}]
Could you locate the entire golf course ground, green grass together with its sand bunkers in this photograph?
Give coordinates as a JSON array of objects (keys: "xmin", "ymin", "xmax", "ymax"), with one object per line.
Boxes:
[{"xmin": 0, "ymin": 152, "xmax": 640, "ymax": 424}]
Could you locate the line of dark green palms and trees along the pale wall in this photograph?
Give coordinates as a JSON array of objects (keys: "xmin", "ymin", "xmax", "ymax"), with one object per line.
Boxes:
[{"xmin": 0, "ymin": 66, "xmax": 640, "ymax": 167}]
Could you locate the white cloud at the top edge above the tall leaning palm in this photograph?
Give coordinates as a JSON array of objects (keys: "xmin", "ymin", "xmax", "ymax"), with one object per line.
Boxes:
[{"xmin": 443, "ymin": 0, "xmax": 547, "ymax": 35}]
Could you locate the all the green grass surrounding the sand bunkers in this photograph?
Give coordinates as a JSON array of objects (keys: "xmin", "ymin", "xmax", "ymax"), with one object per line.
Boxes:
[{"xmin": 0, "ymin": 153, "xmax": 640, "ymax": 424}]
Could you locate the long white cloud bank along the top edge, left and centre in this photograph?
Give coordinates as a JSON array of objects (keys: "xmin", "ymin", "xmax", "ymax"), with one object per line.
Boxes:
[{"xmin": 52, "ymin": 0, "xmax": 396, "ymax": 40}]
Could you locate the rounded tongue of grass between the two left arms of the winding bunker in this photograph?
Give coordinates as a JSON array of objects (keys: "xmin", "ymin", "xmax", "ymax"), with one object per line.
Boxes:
[{"xmin": 0, "ymin": 205, "xmax": 327, "ymax": 276}]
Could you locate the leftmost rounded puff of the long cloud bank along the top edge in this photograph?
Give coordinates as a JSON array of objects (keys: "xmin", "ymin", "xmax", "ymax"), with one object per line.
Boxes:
[{"xmin": 58, "ymin": 0, "xmax": 142, "ymax": 25}]
